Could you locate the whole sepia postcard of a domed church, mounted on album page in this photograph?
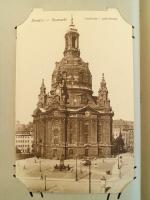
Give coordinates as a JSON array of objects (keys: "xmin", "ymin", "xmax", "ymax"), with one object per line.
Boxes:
[{"xmin": 15, "ymin": 9, "xmax": 134, "ymax": 194}]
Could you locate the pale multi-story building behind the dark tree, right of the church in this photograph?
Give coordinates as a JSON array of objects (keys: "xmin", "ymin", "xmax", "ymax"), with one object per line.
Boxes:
[{"xmin": 113, "ymin": 119, "xmax": 134, "ymax": 152}]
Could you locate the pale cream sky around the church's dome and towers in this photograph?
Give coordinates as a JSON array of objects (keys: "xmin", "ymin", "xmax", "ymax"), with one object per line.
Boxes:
[{"xmin": 16, "ymin": 9, "xmax": 134, "ymax": 123}]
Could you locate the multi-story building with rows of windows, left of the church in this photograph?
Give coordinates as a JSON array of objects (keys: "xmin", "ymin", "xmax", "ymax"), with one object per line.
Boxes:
[{"xmin": 15, "ymin": 122, "xmax": 33, "ymax": 154}]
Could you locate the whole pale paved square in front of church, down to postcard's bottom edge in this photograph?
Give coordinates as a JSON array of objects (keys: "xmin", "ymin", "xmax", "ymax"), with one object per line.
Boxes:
[{"xmin": 16, "ymin": 154, "xmax": 134, "ymax": 193}]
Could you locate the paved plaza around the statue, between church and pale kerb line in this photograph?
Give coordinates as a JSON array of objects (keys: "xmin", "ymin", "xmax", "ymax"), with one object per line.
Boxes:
[{"xmin": 16, "ymin": 158, "xmax": 116, "ymax": 179}]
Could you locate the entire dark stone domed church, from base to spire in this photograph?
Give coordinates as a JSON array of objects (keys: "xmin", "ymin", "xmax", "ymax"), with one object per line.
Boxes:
[{"xmin": 33, "ymin": 19, "xmax": 114, "ymax": 159}]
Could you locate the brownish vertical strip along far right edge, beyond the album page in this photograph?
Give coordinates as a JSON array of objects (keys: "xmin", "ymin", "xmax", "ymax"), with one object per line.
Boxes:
[{"xmin": 141, "ymin": 0, "xmax": 150, "ymax": 200}]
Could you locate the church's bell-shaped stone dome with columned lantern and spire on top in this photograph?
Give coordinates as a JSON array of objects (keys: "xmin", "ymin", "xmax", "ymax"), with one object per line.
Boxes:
[{"xmin": 52, "ymin": 18, "xmax": 92, "ymax": 93}]
